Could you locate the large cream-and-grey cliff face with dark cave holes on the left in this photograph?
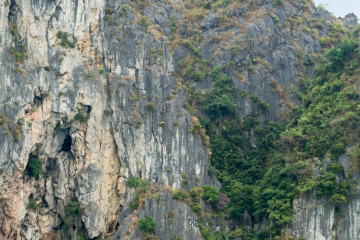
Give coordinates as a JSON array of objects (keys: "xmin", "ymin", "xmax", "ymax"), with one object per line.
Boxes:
[{"xmin": 0, "ymin": 0, "xmax": 217, "ymax": 239}]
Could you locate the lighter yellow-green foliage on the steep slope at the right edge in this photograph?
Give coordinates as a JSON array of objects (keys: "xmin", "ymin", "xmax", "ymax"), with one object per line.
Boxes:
[{"xmin": 283, "ymin": 32, "xmax": 360, "ymax": 160}]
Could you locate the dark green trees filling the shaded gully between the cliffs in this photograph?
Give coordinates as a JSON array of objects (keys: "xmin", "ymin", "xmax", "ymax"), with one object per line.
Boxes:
[{"xmin": 189, "ymin": 67, "xmax": 290, "ymax": 236}]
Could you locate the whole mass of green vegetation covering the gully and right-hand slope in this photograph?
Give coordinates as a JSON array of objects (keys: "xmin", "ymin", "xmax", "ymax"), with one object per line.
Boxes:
[{"xmin": 184, "ymin": 25, "xmax": 360, "ymax": 239}]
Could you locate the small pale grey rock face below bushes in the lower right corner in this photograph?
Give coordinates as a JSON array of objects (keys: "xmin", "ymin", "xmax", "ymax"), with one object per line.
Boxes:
[{"xmin": 292, "ymin": 155, "xmax": 360, "ymax": 240}]
